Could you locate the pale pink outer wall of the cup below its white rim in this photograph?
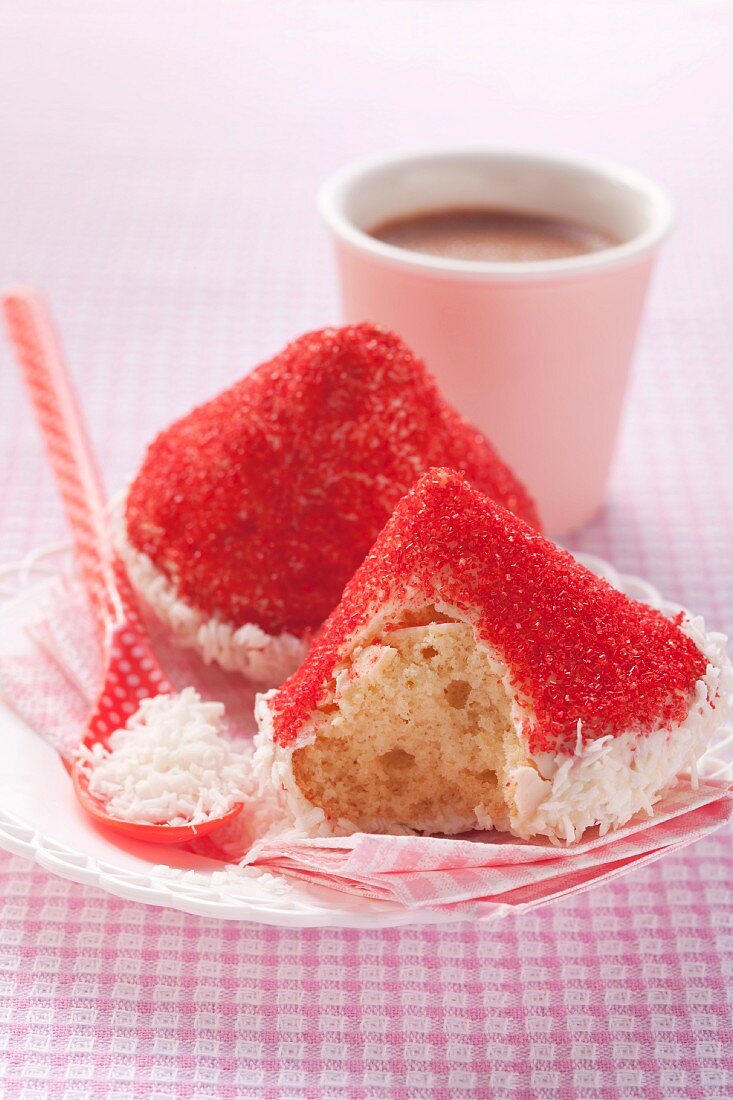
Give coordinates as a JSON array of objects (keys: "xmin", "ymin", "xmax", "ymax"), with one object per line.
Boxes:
[{"xmin": 339, "ymin": 245, "xmax": 653, "ymax": 532}]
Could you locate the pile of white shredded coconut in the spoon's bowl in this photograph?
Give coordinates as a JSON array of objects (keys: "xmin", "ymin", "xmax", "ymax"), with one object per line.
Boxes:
[{"xmin": 79, "ymin": 688, "xmax": 253, "ymax": 825}]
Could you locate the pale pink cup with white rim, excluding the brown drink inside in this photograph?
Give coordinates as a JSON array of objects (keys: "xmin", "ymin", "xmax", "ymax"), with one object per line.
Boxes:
[{"xmin": 319, "ymin": 149, "xmax": 670, "ymax": 535}]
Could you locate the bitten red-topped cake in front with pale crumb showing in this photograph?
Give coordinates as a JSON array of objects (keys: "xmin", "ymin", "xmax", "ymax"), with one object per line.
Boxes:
[{"xmin": 255, "ymin": 470, "xmax": 730, "ymax": 843}]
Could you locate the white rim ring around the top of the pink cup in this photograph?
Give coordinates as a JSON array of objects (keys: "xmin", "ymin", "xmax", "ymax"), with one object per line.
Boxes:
[{"xmin": 317, "ymin": 145, "xmax": 674, "ymax": 282}]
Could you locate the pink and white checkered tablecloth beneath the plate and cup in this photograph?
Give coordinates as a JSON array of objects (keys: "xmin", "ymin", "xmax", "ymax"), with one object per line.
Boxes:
[{"xmin": 0, "ymin": 0, "xmax": 733, "ymax": 1100}]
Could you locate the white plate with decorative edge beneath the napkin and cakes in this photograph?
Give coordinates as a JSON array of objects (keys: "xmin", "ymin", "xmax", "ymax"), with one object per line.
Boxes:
[{"xmin": 0, "ymin": 547, "xmax": 733, "ymax": 928}]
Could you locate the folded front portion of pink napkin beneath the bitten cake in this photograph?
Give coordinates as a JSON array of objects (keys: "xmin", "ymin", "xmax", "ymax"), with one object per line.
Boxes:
[{"xmin": 246, "ymin": 782, "xmax": 733, "ymax": 908}]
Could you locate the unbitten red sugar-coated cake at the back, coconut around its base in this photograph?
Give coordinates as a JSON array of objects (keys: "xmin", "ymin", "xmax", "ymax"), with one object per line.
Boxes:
[{"xmin": 119, "ymin": 325, "xmax": 538, "ymax": 683}]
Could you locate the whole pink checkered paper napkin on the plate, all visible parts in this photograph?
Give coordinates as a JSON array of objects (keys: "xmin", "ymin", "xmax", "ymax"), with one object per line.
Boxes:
[{"xmin": 0, "ymin": 581, "xmax": 733, "ymax": 916}]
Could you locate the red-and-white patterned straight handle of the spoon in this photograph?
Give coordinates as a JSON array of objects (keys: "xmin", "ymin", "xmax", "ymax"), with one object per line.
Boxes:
[{"xmin": 2, "ymin": 288, "xmax": 130, "ymax": 637}]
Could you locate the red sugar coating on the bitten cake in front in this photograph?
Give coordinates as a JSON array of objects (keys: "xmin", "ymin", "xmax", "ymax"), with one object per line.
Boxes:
[{"xmin": 274, "ymin": 470, "xmax": 707, "ymax": 752}]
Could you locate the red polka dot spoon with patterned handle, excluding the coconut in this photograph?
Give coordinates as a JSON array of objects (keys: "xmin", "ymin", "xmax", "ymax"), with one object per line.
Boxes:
[{"xmin": 3, "ymin": 289, "xmax": 242, "ymax": 844}]
